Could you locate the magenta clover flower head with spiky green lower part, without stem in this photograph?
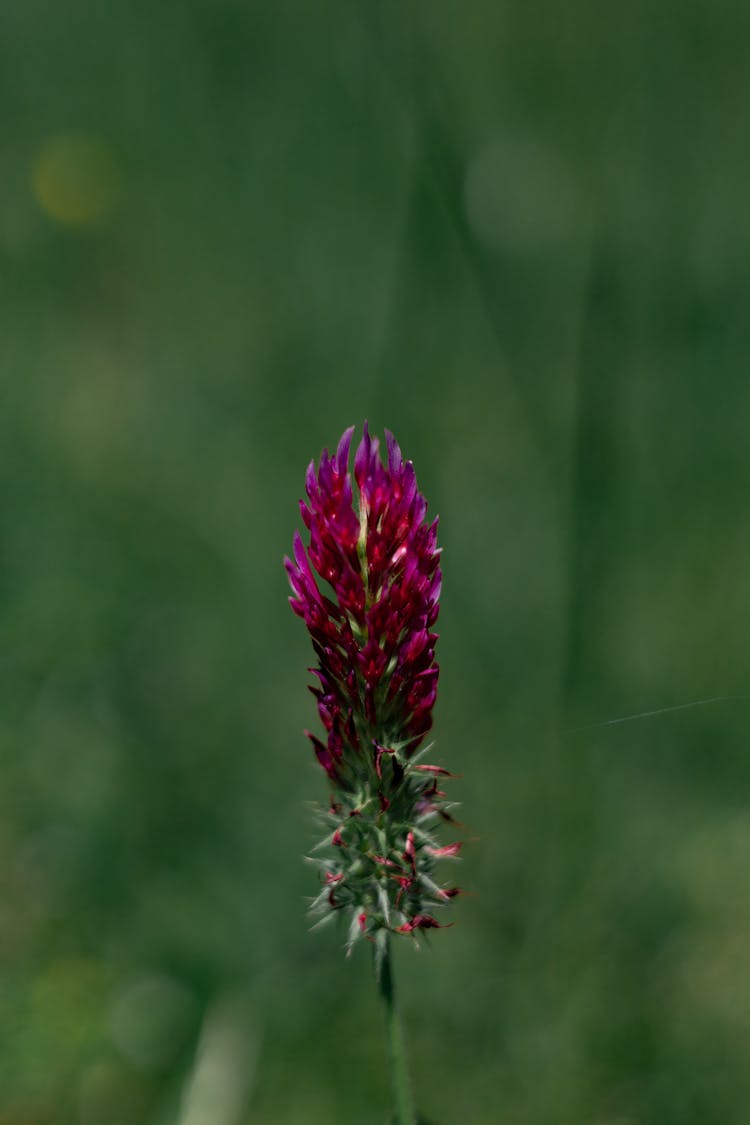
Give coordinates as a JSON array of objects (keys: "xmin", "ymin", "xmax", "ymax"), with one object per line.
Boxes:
[{"xmin": 284, "ymin": 423, "xmax": 461, "ymax": 948}]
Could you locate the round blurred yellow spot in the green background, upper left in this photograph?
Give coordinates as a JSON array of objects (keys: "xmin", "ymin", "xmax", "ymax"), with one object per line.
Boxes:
[{"xmin": 31, "ymin": 132, "xmax": 119, "ymax": 226}]
